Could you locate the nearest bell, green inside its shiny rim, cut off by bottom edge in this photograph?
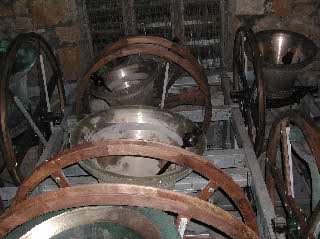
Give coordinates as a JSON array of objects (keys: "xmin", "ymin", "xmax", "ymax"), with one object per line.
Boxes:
[{"xmin": 8, "ymin": 206, "xmax": 164, "ymax": 239}]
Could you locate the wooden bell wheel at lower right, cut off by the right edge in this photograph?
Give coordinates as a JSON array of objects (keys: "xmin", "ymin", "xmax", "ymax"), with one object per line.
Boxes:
[{"xmin": 266, "ymin": 111, "xmax": 320, "ymax": 238}]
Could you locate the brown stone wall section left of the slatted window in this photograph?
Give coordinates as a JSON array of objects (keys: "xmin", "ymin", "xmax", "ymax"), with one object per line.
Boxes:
[{"xmin": 0, "ymin": 0, "xmax": 92, "ymax": 80}]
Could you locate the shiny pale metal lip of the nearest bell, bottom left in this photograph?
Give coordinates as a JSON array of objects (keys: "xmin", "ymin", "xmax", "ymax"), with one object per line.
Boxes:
[{"xmin": 15, "ymin": 206, "xmax": 164, "ymax": 239}]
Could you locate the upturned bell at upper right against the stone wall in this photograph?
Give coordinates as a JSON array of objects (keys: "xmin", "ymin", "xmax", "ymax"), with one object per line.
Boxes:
[{"xmin": 255, "ymin": 30, "xmax": 317, "ymax": 98}]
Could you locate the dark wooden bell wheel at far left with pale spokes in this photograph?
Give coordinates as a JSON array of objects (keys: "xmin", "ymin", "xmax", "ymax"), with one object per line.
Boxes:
[{"xmin": 0, "ymin": 33, "xmax": 65, "ymax": 184}]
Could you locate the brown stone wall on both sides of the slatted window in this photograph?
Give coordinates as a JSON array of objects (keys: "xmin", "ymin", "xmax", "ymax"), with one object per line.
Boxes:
[{"xmin": 0, "ymin": 0, "xmax": 320, "ymax": 74}]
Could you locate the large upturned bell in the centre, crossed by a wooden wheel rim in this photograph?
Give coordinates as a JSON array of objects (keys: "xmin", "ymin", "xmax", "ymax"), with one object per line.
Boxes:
[{"xmin": 71, "ymin": 106, "xmax": 206, "ymax": 187}]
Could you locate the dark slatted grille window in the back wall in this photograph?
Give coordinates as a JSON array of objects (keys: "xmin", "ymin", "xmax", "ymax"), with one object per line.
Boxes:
[{"xmin": 86, "ymin": 0, "xmax": 225, "ymax": 69}]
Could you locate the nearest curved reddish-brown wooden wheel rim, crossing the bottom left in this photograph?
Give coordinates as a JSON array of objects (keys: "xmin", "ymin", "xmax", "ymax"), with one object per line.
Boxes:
[{"xmin": 0, "ymin": 184, "xmax": 258, "ymax": 239}]
